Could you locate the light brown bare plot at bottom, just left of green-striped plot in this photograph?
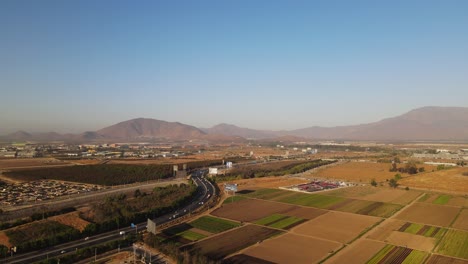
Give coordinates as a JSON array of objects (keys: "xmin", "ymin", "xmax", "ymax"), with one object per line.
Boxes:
[{"xmin": 327, "ymin": 239, "xmax": 385, "ymax": 264}]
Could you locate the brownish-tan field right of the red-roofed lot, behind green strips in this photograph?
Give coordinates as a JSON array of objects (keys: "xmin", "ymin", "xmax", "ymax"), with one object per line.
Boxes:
[{"xmin": 324, "ymin": 186, "xmax": 421, "ymax": 205}]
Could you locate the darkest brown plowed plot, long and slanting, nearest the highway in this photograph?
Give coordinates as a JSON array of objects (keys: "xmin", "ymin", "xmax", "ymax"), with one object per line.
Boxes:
[{"xmin": 181, "ymin": 225, "xmax": 281, "ymax": 260}]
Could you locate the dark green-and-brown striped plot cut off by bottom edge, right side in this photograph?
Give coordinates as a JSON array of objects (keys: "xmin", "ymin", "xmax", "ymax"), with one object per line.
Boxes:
[{"xmin": 367, "ymin": 245, "xmax": 429, "ymax": 264}]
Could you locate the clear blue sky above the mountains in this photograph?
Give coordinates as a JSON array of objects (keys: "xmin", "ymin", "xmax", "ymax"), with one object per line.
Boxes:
[{"xmin": 0, "ymin": 0, "xmax": 468, "ymax": 134}]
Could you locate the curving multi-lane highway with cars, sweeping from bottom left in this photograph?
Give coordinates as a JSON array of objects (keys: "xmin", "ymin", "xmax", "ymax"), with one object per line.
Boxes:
[{"xmin": 0, "ymin": 170, "xmax": 215, "ymax": 263}]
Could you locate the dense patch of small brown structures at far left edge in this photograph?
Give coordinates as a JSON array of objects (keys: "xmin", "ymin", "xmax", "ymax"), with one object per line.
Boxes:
[{"xmin": 0, "ymin": 180, "xmax": 103, "ymax": 206}]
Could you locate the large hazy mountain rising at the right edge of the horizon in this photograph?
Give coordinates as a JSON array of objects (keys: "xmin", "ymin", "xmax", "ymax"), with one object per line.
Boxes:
[{"xmin": 289, "ymin": 107, "xmax": 468, "ymax": 141}]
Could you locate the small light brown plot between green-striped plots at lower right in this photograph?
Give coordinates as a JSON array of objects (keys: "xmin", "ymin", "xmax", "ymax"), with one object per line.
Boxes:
[{"xmin": 386, "ymin": 231, "xmax": 436, "ymax": 252}]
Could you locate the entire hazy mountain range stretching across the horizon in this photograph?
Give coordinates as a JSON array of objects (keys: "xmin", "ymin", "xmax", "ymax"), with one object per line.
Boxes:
[{"xmin": 0, "ymin": 107, "xmax": 468, "ymax": 142}]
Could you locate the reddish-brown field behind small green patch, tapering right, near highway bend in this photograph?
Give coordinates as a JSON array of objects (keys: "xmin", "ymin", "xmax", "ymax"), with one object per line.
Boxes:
[{"xmin": 211, "ymin": 199, "xmax": 326, "ymax": 222}]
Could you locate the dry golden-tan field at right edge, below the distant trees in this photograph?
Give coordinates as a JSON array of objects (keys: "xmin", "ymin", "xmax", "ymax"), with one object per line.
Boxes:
[{"xmin": 399, "ymin": 167, "xmax": 468, "ymax": 194}]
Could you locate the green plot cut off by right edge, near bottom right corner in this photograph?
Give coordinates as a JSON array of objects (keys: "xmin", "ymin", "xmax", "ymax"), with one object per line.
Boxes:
[{"xmin": 436, "ymin": 229, "xmax": 468, "ymax": 260}]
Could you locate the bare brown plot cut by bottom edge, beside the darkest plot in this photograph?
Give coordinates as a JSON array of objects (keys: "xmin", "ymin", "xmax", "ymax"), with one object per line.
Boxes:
[{"xmin": 243, "ymin": 233, "xmax": 341, "ymax": 263}]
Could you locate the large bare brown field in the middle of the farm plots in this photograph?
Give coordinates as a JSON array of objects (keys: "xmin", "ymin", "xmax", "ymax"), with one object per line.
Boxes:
[{"xmin": 291, "ymin": 212, "xmax": 380, "ymax": 243}]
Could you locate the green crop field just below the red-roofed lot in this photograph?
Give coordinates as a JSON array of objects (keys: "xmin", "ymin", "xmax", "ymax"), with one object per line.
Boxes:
[{"xmin": 278, "ymin": 193, "xmax": 346, "ymax": 208}]
